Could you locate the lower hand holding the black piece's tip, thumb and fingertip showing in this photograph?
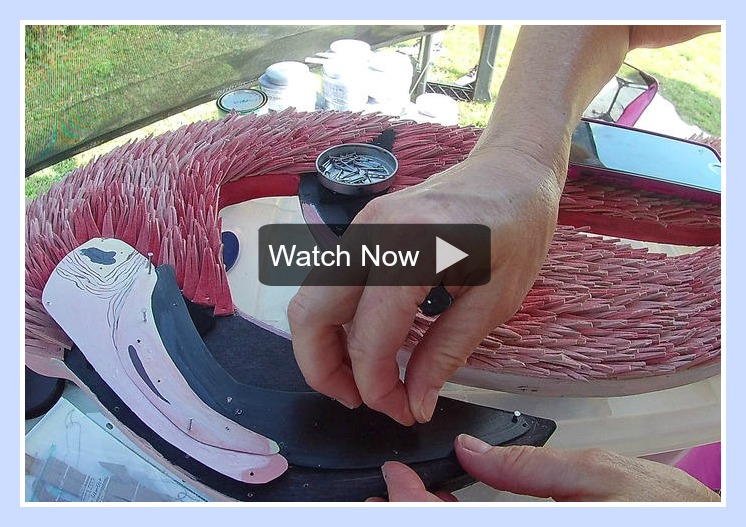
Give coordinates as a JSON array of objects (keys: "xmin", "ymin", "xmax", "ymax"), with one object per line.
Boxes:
[{"xmin": 368, "ymin": 435, "xmax": 720, "ymax": 502}]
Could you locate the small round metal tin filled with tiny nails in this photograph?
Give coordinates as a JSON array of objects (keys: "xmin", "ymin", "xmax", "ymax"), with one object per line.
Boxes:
[{"xmin": 316, "ymin": 143, "xmax": 399, "ymax": 196}]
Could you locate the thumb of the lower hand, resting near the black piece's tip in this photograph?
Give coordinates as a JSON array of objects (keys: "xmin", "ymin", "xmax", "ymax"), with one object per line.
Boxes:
[{"xmin": 456, "ymin": 434, "xmax": 606, "ymax": 501}]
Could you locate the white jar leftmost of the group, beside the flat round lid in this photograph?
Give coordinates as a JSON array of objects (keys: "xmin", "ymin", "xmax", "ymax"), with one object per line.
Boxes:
[{"xmin": 259, "ymin": 61, "xmax": 318, "ymax": 112}]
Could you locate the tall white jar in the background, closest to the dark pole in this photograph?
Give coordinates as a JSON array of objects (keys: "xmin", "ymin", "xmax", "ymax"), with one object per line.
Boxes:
[{"xmin": 368, "ymin": 50, "xmax": 414, "ymax": 114}]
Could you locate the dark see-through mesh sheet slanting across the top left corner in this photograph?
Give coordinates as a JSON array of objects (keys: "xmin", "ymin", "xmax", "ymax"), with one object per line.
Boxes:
[{"xmin": 25, "ymin": 25, "xmax": 445, "ymax": 175}]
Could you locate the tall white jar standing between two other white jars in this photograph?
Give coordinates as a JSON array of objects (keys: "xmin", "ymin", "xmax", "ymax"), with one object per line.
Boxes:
[{"xmin": 321, "ymin": 39, "xmax": 371, "ymax": 112}]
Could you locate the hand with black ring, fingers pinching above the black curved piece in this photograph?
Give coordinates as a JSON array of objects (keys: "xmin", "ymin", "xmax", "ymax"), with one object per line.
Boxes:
[{"xmin": 288, "ymin": 147, "xmax": 561, "ymax": 425}]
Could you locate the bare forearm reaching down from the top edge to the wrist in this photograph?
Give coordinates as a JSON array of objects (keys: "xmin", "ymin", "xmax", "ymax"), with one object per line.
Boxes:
[{"xmin": 475, "ymin": 26, "xmax": 629, "ymax": 187}]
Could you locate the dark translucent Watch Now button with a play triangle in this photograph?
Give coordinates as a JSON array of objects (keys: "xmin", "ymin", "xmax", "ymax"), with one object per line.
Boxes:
[{"xmin": 258, "ymin": 224, "xmax": 491, "ymax": 286}]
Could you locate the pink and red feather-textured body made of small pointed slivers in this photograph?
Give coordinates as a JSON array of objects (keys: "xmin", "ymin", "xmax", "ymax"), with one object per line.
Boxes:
[{"xmin": 25, "ymin": 111, "xmax": 720, "ymax": 381}]
